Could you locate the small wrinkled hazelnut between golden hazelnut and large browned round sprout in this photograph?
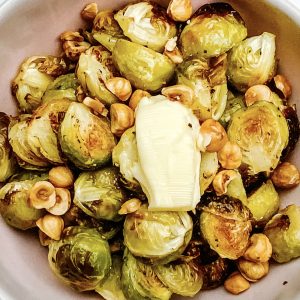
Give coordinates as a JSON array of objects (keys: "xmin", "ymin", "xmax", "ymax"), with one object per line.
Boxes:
[{"xmin": 218, "ymin": 141, "xmax": 242, "ymax": 169}]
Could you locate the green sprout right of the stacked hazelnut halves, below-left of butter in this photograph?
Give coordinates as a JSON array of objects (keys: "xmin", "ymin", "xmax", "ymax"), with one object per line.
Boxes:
[{"xmin": 74, "ymin": 167, "xmax": 126, "ymax": 221}]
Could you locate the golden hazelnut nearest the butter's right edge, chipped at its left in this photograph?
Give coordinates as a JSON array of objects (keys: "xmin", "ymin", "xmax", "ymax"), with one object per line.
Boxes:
[{"xmin": 200, "ymin": 119, "xmax": 228, "ymax": 152}]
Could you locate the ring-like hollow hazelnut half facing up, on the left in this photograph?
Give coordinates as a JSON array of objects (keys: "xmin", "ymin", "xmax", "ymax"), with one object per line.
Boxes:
[{"xmin": 29, "ymin": 181, "xmax": 56, "ymax": 209}]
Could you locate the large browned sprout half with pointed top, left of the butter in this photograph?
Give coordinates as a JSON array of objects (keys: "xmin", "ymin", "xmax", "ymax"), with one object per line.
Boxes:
[{"xmin": 59, "ymin": 102, "xmax": 115, "ymax": 169}]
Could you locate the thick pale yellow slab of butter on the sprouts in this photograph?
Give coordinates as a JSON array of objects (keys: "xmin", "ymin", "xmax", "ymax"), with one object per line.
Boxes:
[{"xmin": 133, "ymin": 95, "xmax": 201, "ymax": 211}]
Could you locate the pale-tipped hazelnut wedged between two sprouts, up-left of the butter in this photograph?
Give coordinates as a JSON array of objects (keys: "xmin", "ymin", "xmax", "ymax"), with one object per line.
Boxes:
[{"xmin": 105, "ymin": 77, "xmax": 132, "ymax": 101}]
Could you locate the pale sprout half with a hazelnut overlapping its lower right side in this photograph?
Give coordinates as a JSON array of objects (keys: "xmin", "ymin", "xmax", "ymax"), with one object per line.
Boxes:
[{"xmin": 76, "ymin": 46, "xmax": 118, "ymax": 105}]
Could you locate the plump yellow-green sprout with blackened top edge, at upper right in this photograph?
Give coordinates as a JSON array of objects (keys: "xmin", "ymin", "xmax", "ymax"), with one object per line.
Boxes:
[{"xmin": 179, "ymin": 3, "xmax": 247, "ymax": 58}]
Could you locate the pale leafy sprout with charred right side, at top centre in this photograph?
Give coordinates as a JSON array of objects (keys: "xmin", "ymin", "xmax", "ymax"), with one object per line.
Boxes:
[{"xmin": 115, "ymin": 1, "xmax": 177, "ymax": 52}]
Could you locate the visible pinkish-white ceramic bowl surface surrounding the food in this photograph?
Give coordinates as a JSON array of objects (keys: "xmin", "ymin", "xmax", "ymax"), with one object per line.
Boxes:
[{"xmin": 0, "ymin": 0, "xmax": 300, "ymax": 300}]
